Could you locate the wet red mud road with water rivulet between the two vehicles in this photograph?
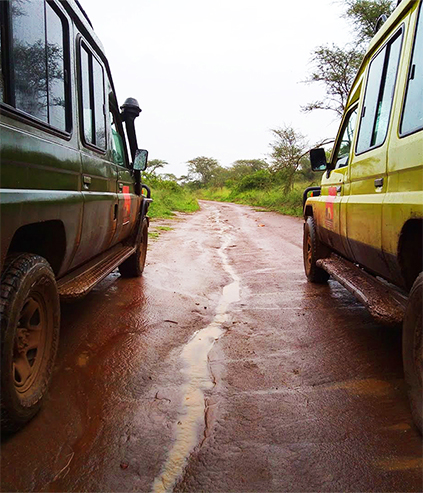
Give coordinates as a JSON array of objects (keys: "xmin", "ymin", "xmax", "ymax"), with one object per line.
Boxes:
[{"xmin": 1, "ymin": 202, "xmax": 423, "ymax": 492}]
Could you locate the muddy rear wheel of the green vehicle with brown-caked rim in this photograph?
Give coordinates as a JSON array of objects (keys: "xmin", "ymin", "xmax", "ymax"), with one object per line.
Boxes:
[{"xmin": 0, "ymin": 253, "xmax": 60, "ymax": 431}]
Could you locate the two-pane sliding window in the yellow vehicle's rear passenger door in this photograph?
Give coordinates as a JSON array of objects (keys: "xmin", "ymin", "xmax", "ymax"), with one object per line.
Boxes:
[{"xmin": 357, "ymin": 30, "xmax": 402, "ymax": 154}]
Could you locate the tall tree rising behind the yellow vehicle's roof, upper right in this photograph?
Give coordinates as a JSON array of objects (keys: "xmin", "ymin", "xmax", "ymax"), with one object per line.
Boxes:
[{"xmin": 302, "ymin": 0, "xmax": 395, "ymax": 115}]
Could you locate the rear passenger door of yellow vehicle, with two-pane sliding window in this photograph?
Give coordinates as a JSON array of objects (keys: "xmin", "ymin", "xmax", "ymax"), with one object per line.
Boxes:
[{"xmin": 346, "ymin": 27, "xmax": 403, "ymax": 275}]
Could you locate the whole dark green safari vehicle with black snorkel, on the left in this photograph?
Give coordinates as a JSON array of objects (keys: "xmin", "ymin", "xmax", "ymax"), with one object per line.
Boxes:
[{"xmin": 0, "ymin": 0, "xmax": 151, "ymax": 430}]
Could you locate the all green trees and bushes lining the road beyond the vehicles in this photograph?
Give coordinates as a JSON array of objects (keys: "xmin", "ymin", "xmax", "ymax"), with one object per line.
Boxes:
[{"xmin": 144, "ymin": 0, "xmax": 397, "ymax": 218}]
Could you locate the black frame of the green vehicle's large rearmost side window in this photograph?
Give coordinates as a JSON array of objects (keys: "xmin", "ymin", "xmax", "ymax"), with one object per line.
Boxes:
[{"xmin": 0, "ymin": 0, "xmax": 73, "ymax": 140}]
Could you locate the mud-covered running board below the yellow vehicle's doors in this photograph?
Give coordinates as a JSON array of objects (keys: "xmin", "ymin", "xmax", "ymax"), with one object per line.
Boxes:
[{"xmin": 316, "ymin": 254, "xmax": 407, "ymax": 325}]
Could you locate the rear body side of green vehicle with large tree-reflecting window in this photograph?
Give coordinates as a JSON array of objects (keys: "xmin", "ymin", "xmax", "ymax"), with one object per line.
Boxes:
[{"xmin": 0, "ymin": 0, "xmax": 83, "ymax": 276}]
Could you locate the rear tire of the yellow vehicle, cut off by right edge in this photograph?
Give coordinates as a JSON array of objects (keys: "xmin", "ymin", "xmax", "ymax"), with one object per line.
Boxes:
[{"xmin": 402, "ymin": 272, "xmax": 423, "ymax": 433}]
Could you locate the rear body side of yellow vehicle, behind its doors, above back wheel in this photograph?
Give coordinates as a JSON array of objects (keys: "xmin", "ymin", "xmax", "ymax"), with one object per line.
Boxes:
[{"xmin": 382, "ymin": 2, "xmax": 423, "ymax": 283}]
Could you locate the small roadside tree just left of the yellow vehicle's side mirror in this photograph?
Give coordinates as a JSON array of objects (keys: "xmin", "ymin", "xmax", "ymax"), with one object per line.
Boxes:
[{"xmin": 270, "ymin": 125, "xmax": 309, "ymax": 193}]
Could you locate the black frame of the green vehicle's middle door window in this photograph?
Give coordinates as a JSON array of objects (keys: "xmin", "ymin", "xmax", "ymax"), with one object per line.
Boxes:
[{"xmin": 76, "ymin": 34, "xmax": 108, "ymax": 155}]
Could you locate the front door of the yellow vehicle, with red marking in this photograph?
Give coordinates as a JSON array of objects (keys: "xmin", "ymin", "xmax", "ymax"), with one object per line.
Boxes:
[{"xmin": 317, "ymin": 104, "xmax": 358, "ymax": 255}]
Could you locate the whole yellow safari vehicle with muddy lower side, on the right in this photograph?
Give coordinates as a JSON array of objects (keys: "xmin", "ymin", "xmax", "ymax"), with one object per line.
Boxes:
[{"xmin": 303, "ymin": 0, "xmax": 423, "ymax": 430}]
